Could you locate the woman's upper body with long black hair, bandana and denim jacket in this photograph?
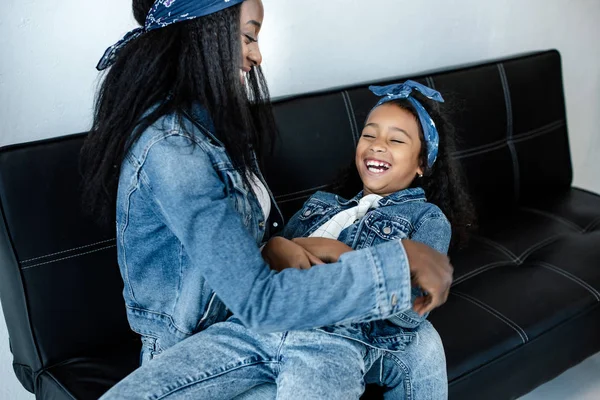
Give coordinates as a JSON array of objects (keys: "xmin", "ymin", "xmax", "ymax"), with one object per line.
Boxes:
[{"xmin": 82, "ymin": 0, "xmax": 452, "ymax": 396}]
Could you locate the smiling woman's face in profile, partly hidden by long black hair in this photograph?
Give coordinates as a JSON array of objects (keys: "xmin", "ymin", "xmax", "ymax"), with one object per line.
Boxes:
[{"xmin": 240, "ymin": 0, "xmax": 265, "ymax": 83}]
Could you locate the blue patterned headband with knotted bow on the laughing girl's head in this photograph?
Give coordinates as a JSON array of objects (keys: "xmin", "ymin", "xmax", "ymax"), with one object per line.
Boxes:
[{"xmin": 369, "ymin": 80, "xmax": 444, "ymax": 168}]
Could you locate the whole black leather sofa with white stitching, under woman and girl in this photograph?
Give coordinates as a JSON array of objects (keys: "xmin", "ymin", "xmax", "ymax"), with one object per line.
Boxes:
[{"xmin": 0, "ymin": 51, "xmax": 600, "ymax": 399}]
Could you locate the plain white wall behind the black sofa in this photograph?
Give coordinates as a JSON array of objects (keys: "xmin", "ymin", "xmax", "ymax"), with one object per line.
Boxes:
[{"xmin": 0, "ymin": 0, "xmax": 600, "ymax": 399}]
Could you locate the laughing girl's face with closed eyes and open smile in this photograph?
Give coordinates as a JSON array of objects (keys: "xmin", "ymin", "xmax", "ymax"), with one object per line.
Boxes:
[{"xmin": 355, "ymin": 103, "xmax": 423, "ymax": 197}]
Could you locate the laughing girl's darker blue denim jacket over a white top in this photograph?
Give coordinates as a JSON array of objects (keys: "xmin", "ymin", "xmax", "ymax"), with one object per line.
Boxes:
[{"xmin": 283, "ymin": 188, "xmax": 451, "ymax": 351}]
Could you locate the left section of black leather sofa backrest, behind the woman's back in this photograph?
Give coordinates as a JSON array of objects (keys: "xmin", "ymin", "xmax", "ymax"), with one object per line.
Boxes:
[{"xmin": 0, "ymin": 135, "xmax": 137, "ymax": 388}]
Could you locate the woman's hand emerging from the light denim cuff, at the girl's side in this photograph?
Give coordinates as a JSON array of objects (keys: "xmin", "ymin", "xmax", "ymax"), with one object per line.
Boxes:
[{"xmin": 402, "ymin": 240, "xmax": 454, "ymax": 315}]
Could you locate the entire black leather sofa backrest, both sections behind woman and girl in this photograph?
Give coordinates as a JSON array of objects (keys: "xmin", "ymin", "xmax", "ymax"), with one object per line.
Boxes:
[{"xmin": 0, "ymin": 51, "xmax": 571, "ymax": 387}]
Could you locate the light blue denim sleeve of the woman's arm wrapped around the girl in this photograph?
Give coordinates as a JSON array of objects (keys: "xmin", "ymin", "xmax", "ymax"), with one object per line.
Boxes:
[{"xmin": 138, "ymin": 132, "xmax": 411, "ymax": 332}]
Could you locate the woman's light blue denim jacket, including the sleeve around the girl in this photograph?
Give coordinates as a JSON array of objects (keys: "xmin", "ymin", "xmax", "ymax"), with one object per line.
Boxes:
[{"xmin": 116, "ymin": 107, "xmax": 418, "ymax": 356}]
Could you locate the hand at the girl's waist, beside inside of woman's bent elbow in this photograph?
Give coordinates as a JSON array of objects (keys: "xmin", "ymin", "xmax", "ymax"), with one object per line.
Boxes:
[{"xmin": 262, "ymin": 236, "xmax": 323, "ymax": 271}]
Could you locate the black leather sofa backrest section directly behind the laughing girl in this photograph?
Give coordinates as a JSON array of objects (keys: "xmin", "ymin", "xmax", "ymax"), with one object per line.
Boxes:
[{"xmin": 265, "ymin": 51, "xmax": 572, "ymax": 219}]
